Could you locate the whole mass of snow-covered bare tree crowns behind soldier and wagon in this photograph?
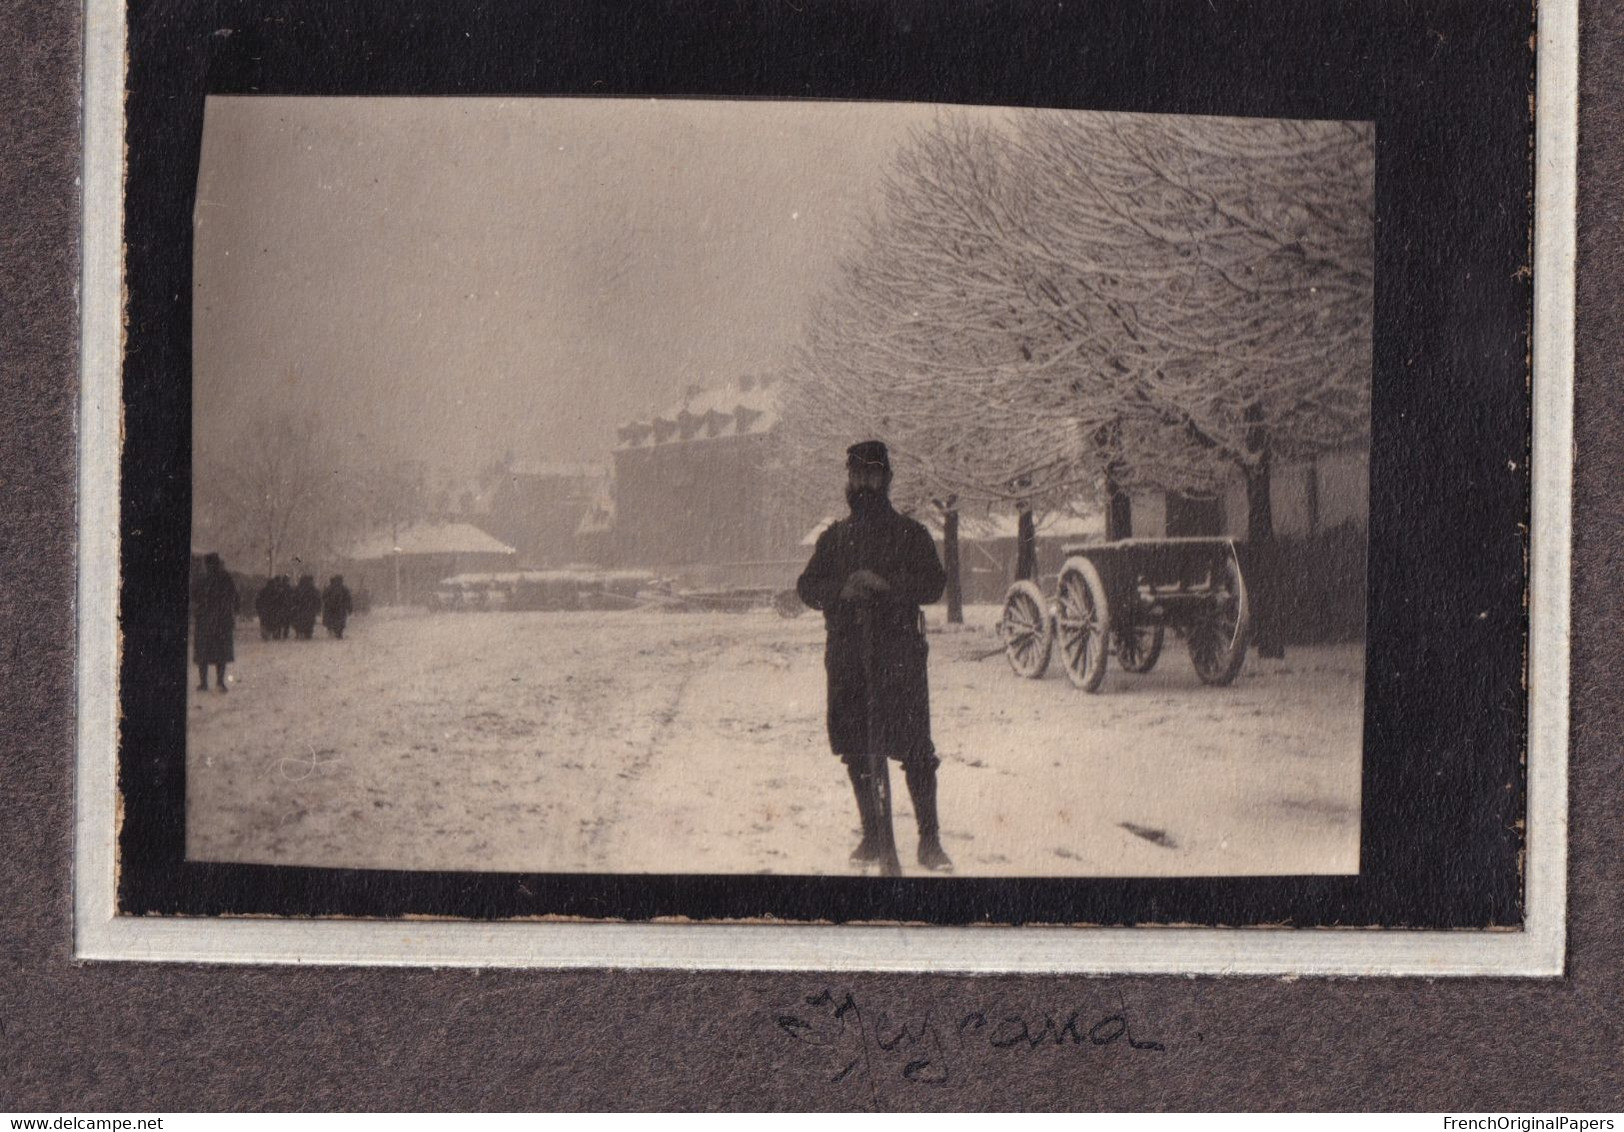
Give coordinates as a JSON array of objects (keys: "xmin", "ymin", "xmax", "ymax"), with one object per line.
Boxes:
[{"xmin": 786, "ymin": 112, "xmax": 1374, "ymax": 639}]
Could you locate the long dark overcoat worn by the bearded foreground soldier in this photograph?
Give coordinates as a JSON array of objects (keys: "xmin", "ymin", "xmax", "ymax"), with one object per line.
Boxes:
[{"xmin": 796, "ymin": 502, "xmax": 945, "ymax": 762}]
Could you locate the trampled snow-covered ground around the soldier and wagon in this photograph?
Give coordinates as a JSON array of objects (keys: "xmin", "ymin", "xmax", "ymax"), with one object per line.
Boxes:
[{"xmin": 187, "ymin": 606, "xmax": 1364, "ymax": 877}]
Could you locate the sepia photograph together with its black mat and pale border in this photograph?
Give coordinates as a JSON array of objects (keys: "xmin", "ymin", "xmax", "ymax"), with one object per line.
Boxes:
[{"xmin": 75, "ymin": 0, "xmax": 1572, "ymax": 976}]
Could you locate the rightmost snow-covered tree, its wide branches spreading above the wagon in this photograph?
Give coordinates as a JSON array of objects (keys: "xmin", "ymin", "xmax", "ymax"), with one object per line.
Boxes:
[{"xmin": 1012, "ymin": 114, "xmax": 1374, "ymax": 541}]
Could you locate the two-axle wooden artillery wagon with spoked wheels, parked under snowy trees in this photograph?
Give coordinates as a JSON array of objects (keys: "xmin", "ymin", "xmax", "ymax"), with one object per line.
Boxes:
[{"xmin": 999, "ymin": 538, "xmax": 1252, "ymax": 692}]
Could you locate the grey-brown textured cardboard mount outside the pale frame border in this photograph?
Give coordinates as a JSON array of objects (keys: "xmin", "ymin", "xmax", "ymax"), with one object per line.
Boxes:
[{"xmin": 0, "ymin": 0, "xmax": 1624, "ymax": 1113}]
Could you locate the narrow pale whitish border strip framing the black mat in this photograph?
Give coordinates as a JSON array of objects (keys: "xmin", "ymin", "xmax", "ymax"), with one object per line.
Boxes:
[{"xmin": 75, "ymin": 0, "xmax": 1579, "ymax": 976}]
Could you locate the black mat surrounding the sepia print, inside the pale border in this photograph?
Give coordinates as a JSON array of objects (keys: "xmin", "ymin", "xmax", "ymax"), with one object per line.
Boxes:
[{"xmin": 119, "ymin": 0, "xmax": 1533, "ymax": 927}]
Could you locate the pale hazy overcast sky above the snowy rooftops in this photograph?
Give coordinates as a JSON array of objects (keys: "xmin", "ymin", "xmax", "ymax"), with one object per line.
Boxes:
[{"xmin": 193, "ymin": 97, "xmax": 1000, "ymax": 474}]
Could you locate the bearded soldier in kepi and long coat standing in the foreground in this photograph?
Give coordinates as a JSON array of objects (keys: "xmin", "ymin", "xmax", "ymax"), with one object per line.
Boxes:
[{"xmin": 796, "ymin": 440, "xmax": 953, "ymax": 869}]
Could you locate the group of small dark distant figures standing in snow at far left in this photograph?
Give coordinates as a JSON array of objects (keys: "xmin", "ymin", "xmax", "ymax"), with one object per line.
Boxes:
[{"xmin": 192, "ymin": 554, "xmax": 367, "ymax": 692}]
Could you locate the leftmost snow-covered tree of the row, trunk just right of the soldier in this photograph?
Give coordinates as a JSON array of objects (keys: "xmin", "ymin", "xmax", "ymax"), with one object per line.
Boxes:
[{"xmin": 784, "ymin": 117, "xmax": 1098, "ymax": 604}]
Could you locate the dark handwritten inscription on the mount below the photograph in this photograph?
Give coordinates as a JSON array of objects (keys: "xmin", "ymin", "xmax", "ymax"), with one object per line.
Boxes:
[{"xmin": 773, "ymin": 987, "xmax": 1168, "ymax": 1108}]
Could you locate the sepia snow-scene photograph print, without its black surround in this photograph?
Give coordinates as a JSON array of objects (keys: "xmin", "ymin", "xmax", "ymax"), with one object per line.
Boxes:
[{"xmin": 184, "ymin": 94, "xmax": 1377, "ymax": 880}]
